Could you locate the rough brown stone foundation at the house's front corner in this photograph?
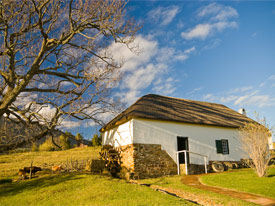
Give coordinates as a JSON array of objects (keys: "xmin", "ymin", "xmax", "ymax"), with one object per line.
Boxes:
[{"xmin": 117, "ymin": 144, "xmax": 177, "ymax": 179}]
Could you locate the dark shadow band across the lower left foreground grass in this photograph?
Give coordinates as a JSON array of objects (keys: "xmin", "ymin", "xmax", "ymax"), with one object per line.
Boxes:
[{"xmin": 0, "ymin": 174, "xmax": 83, "ymax": 197}]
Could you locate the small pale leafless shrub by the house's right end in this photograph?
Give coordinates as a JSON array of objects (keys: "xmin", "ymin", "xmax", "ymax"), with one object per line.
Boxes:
[{"xmin": 239, "ymin": 123, "xmax": 272, "ymax": 177}]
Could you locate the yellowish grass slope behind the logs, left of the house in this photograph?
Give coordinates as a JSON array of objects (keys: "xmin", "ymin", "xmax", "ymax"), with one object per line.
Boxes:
[{"xmin": 0, "ymin": 147, "xmax": 101, "ymax": 180}]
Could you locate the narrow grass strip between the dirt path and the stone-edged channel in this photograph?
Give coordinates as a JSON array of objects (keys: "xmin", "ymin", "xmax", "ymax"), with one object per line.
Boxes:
[{"xmin": 141, "ymin": 176, "xmax": 256, "ymax": 206}]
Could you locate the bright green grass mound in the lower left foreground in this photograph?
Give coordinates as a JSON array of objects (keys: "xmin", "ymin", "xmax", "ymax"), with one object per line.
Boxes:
[{"xmin": 0, "ymin": 174, "xmax": 194, "ymax": 206}]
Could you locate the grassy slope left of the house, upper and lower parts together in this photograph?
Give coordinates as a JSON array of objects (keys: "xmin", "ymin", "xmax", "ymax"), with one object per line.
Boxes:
[{"xmin": 0, "ymin": 147, "xmax": 195, "ymax": 206}]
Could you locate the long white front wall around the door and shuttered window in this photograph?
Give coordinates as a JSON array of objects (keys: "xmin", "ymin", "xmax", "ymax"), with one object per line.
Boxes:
[{"xmin": 132, "ymin": 119, "xmax": 244, "ymax": 164}]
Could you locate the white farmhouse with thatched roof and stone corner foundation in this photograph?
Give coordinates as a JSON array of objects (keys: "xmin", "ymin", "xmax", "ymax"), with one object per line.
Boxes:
[{"xmin": 101, "ymin": 94, "xmax": 272, "ymax": 178}]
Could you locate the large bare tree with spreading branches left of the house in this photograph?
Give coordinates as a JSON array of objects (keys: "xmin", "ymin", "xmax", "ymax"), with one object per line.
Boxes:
[{"xmin": 0, "ymin": 0, "xmax": 139, "ymax": 149}]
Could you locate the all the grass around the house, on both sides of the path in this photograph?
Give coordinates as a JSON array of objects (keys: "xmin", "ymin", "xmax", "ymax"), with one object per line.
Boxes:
[{"xmin": 0, "ymin": 147, "xmax": 275, "ymax": 206}]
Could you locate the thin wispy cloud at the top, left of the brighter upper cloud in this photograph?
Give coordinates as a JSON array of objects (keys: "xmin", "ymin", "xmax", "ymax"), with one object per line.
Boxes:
[{"xmin": 148, "ymin": 6, "xmax": 179, "ymax": 26}]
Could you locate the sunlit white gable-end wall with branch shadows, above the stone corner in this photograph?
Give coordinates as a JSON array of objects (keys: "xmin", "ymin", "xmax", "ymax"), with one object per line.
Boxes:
[{"xmin": 102, "ymin": 120, "xmax": 133, "ymax": 147}]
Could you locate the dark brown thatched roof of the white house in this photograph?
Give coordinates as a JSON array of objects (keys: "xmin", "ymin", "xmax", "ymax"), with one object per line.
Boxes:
[{"xmin": 100, "ymin": 94, "xmax": 254, "ymax": 131}]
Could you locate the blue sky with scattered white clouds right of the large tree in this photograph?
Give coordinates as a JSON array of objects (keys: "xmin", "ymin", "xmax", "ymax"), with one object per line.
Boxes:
[{"xmin": 69, "ymin": 1, "xmax": 275, "ymax": 141}]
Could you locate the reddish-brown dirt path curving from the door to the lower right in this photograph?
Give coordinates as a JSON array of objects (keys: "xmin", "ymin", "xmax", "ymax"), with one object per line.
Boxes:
[{"xmin": 182, "ymin": 175, "xmax": 275, "ymax": 206}]
